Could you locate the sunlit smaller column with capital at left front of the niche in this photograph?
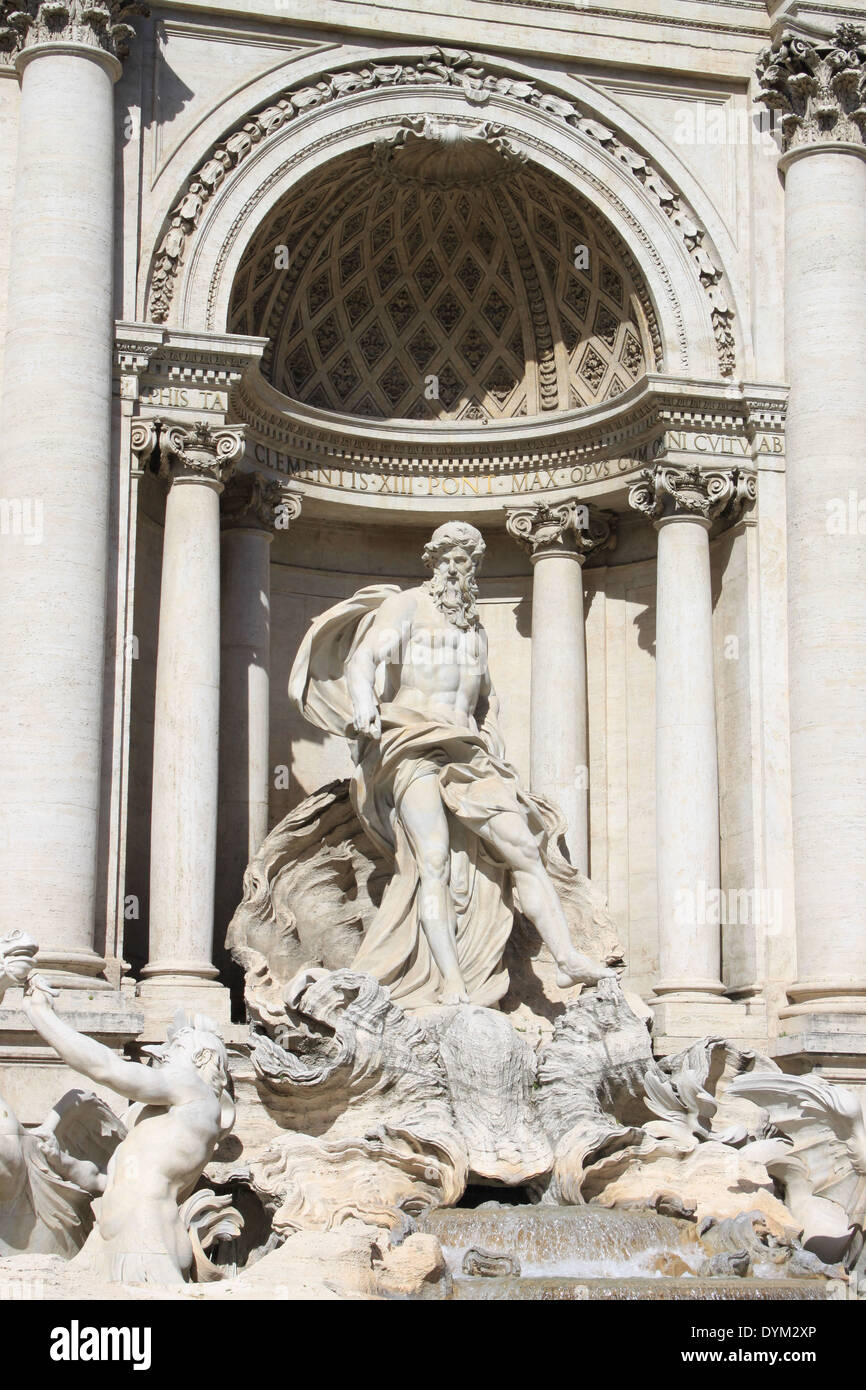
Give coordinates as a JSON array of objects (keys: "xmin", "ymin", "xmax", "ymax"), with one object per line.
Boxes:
[{"xmin": 140, "ymin": 423, "xmax": 243, "ymax": 1017}]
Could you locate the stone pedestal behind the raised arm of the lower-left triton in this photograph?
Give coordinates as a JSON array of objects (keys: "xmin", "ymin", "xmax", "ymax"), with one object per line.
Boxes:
[{"xmin": 0, "ymin": 981, "xmax": 145, "ymax": 1125}]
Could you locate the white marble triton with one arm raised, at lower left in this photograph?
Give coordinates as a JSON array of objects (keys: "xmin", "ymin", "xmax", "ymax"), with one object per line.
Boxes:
[{"xmin": 24, "ymin": 972, "xmax": 236, "ymax": 1284}]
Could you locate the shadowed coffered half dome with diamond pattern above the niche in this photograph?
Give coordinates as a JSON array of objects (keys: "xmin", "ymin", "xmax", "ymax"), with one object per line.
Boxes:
[{"xmin": 229, "ymin": 129, "xmax": 660, "ymax": 424}]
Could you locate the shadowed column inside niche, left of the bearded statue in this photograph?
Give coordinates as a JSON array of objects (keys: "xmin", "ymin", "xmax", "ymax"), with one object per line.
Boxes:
[{"xmin": 217, "ymin": 473, "xmax": 300, "ymax": 961}]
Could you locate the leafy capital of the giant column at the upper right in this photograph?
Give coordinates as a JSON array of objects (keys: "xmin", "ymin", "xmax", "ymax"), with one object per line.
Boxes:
[{"xmin": 756, "ymin": 24, "xmax": 866, "ymax": 154}]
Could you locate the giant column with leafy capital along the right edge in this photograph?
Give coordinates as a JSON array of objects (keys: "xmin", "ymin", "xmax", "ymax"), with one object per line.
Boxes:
[{"xmin": 758, "ymin": 25, "xmax": 866, "ymax": 1052}]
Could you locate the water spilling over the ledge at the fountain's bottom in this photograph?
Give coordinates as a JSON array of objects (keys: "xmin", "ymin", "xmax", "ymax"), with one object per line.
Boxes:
[{"xmin": 420, "ymin": 1204, "xmax": 840, "ymax": 1301}]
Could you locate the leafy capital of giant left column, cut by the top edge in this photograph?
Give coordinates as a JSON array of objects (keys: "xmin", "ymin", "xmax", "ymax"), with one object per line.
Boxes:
[{"xmin": 0, "ymin": 0, "xmax": 144, "ymax": 58}]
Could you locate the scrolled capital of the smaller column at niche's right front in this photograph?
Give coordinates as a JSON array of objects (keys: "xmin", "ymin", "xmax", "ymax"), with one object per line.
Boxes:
[{"xmin": 628, "ymin": 463, "xmax": 758, "ymax": 528}]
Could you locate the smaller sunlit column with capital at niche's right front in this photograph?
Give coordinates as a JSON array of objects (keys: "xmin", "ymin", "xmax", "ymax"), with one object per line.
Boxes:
[{"xmin": 628, "ymin": 464, "xmax": 753, "ymax": 1034}]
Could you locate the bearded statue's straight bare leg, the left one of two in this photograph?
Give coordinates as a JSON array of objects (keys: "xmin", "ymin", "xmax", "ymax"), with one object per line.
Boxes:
[{"xmin": 399, "ymin": 776, "xmax": 468, "ymax": 1004}]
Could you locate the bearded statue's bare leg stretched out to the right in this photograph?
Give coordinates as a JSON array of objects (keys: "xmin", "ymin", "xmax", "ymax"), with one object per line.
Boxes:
[{"xmin": 484, "ymin": 810, "xmax": 613, "ymax": 988}]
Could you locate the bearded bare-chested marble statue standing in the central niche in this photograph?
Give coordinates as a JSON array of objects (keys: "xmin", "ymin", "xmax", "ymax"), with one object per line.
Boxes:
[{"xmin": 289, "ymin": 521, "xmax": 612, "ymax": 1006}]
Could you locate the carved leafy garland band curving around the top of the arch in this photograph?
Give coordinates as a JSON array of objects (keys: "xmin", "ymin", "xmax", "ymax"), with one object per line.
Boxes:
[{"xmin": 149, "ymin": 49, "xmax": 735, "ymax": 377}]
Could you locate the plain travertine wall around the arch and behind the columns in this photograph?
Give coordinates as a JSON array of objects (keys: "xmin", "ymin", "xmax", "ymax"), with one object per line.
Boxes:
[{"xmin": 0, "ymin": 0, "xmax": 811, "ymax": 1045}]
